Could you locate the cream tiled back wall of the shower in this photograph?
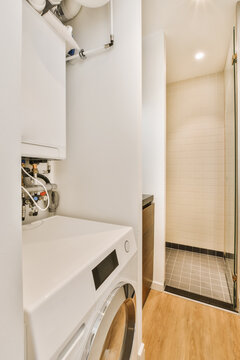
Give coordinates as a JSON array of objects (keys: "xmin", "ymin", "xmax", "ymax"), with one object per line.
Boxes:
[{"xmin": 166, "ymin": 73, "xmax": 224, "ymax": 251}]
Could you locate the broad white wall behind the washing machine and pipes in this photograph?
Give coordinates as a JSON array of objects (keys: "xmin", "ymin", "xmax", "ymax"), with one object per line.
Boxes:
[{"xmin": 55, "ymin": 0, "xmax": 142, "ymax": 348}]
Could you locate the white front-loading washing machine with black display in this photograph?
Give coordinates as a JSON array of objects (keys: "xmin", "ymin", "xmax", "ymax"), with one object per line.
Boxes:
[{"xmin": 23, "ymin": 216, "xmax": 139, "ymax": 360}]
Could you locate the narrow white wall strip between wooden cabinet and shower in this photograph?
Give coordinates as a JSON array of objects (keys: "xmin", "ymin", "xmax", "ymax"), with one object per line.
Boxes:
[{"xmin": 142, "ymin": 31, "xmax": 166, "ymax": 290}]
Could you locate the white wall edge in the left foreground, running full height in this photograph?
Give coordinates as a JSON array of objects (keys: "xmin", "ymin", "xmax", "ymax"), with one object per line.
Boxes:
[{"xmin": 0, "ymin": 0, "xmax": 24, "ymax": 360}]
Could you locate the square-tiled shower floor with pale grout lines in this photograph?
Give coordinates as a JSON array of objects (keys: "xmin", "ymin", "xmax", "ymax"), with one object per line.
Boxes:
[{"xmin": 165, "ymin": 248, "xmax": 231, "ymax": 303}]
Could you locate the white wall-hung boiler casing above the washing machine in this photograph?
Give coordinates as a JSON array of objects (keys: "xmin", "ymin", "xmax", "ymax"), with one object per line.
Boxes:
[{"xmin": 22, "ymin": 0, "xmax": 66, "ymax": 159}]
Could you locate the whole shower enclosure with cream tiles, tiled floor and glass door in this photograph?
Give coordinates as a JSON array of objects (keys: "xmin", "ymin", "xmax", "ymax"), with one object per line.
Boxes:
[{"xmin": 165, "ymin": 27, "xmax": 238, "ymax": 310}]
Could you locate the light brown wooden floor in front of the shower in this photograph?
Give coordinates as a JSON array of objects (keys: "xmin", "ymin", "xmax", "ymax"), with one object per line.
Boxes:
[{"xmin": 143, "ymin": 290, "xmax": 240, "ymax": 360}]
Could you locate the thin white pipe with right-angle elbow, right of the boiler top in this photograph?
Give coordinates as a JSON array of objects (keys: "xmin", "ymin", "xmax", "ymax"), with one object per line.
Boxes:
[{"xmin": 66, "ymin": 0, "xmax": 114, "ymax": 62}]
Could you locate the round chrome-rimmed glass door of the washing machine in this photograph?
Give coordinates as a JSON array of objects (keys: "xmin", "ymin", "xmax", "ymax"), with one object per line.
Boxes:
[{"xmin": 83, "ymin": 283, "xmax": 136, "ymax": 360}]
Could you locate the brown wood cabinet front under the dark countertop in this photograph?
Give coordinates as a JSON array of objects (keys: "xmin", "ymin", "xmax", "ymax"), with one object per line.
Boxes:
[{"xmin": 142, "ymin": 204, "xmax": 154, "ymax": 305}]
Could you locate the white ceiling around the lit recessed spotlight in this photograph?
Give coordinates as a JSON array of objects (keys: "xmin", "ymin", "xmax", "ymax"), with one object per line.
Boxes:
[{"xmin": 142, "ymin": 0, "xmax": 236, "ymax": 83}]
